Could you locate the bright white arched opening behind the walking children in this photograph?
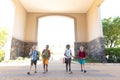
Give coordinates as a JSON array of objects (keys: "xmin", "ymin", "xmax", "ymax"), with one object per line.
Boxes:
[{"xmin": 37, "ymin": 15, "xmax": 75, "ymax": 60}]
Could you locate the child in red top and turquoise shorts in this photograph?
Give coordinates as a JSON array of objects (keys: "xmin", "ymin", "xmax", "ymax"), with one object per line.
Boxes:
[{"xmin": 78, "ymin": 46, "xmax": 86, "ymax": 73}]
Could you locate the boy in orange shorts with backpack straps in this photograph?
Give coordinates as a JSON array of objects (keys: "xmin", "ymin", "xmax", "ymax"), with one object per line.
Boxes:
[{"xmin": 42, "ymin": 45, "xmax": 50, "ymax": 73}]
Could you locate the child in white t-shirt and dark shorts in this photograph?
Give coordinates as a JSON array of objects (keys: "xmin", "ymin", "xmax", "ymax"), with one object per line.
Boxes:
[{"xmin": 64, "ymin": 44, "xmax": 72, "ymax": 73}]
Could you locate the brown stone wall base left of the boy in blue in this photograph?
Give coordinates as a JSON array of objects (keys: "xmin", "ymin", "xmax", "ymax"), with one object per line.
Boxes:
[{"xmin": 10, "ymin": 38, "xmax": 37, "ymax": 59}]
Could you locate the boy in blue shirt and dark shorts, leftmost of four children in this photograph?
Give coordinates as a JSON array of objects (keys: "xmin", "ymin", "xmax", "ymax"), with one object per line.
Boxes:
[{"xmin": 27, "ymin": 46, "xmax": 39, "ymax": 75}]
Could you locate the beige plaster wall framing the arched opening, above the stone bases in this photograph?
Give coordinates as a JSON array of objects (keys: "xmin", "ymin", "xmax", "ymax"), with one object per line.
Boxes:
[{"xmin": 25, "ymin": 13, "xmax": 87, "ymax": 42}]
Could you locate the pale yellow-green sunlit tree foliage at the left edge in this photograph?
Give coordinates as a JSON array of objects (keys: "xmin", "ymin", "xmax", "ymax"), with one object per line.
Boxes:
[{"xmin": 0, "ymin": 27, "xmax": 8, "ymax": 49}]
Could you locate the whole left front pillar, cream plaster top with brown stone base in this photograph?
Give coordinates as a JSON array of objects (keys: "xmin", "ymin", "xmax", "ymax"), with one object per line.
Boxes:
[{"xmin": 10, "ymin": 0, "xmax": 27, "ymax": 59}]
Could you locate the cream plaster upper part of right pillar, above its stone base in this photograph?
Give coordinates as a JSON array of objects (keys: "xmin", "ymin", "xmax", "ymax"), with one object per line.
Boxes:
[{"xmin": 87, "ymin": 0, "xmax": 103, "ymax": 42}]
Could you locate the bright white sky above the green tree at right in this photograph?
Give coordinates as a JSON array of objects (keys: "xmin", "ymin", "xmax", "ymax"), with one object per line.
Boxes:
[{"xmin": 101, "ymin": 0, "xmax": 120, "ymax": 19}]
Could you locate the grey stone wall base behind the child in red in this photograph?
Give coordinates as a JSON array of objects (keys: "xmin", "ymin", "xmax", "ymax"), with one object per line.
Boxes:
[{"xmin": 75, "ymin": 37, "xmax": 105, "ymax": 62}]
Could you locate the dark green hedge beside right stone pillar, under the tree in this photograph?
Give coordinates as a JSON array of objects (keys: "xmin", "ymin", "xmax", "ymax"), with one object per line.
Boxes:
[{"xmin": 105, "ymin": 48, "xmax": 120, "ymax": 63}]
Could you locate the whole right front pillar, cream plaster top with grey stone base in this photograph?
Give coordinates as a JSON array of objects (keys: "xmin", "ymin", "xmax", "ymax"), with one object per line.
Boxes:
[{"xmin": 87, "ymin": 0, "xmax": 106, "ymax": 62}]
